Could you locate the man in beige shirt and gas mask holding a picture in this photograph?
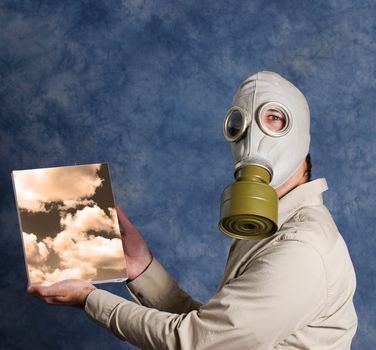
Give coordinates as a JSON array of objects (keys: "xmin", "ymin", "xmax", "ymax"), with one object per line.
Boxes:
[{"xmin": 28, "ymin": 72, "xmax": 357, "ymax": 350}]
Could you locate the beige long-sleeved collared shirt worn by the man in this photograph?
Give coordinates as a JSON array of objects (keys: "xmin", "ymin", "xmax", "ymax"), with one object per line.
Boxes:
[{"xmin": 85, "ymin": 179, "xmax": 357, "ymax": 350}]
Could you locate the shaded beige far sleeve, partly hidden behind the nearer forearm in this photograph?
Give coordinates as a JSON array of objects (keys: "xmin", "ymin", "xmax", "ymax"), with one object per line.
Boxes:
[{"xmin": 127, "ymin": 257, "xmax": 201, "ymax": 314}]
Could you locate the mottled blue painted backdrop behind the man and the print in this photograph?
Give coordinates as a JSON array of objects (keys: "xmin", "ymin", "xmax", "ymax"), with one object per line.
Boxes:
[{"xmin": 0, "ymin": 0, "xmax": 376, "ymax": 350}]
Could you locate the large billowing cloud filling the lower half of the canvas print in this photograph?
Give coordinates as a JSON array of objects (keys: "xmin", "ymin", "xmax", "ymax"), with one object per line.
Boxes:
[{"xmin": 24, "ymin": 206, "xmax": 126, "ymax": 285}]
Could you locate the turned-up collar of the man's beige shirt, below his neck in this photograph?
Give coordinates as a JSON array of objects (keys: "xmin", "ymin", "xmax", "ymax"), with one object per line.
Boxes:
[{"xmin": 278, "ymin": 178, "xmax": 328, "ymax": 228}]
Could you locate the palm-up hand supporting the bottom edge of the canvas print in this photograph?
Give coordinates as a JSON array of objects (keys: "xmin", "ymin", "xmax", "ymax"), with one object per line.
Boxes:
[{"xmin": 27, "ymin": 279, "xmax": 96, "ymax": 308}]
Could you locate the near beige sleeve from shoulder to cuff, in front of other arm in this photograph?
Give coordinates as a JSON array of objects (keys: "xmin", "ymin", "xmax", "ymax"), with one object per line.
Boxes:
[{"xmin": 85, "ymin": 242, "xmax": 327, "ymax": 350}]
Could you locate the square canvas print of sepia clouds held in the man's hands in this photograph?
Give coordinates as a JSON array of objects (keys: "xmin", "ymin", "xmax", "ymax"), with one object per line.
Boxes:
[{"xmin": 12, "ymin": 163, "xmax": 126, "ymax": 285}]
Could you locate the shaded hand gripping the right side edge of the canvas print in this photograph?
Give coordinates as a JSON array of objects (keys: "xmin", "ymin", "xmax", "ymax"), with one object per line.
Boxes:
[{"xmin": 116, "ymin": 206, "xmax": 153, "ymax": 281}]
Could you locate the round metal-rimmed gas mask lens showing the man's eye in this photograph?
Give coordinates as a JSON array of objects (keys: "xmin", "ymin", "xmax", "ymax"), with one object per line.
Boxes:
[{"xmin": 257, "ymin": 102, "xmax": 291, "ymax": 137}]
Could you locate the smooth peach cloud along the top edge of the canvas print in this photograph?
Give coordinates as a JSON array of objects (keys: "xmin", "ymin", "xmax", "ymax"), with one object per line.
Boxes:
[{"xmin": 13, "ymin": 164, "xmax": 102, "ymax": 212}]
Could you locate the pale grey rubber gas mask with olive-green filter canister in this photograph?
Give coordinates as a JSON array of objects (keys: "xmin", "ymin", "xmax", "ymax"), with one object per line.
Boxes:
[{"xmin": 219, "ymin": 72, "xmax": 310, "ymax": 239}]
